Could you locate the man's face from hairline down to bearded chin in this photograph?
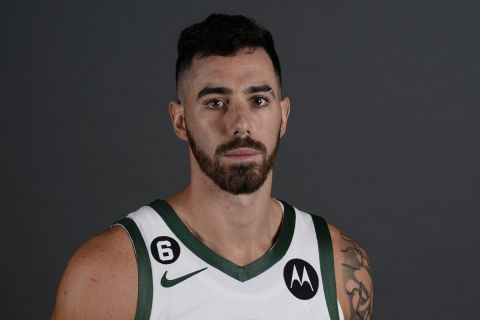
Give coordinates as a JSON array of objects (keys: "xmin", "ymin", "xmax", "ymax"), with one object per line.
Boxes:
[{"xmin": 177, "ymin": 48, "xmax": 289, "ymax": 194}]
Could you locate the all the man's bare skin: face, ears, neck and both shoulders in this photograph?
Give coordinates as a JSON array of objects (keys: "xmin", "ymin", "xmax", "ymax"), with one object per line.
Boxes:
[{"xmin": 52, "ymin": 48, "xmax": 373, "ymax": 320}]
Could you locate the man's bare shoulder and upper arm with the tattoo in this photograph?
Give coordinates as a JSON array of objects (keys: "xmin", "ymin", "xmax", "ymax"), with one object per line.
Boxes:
[{"xmin": 328, "ymin": 224, "xmax": 373, "ymax": 320}]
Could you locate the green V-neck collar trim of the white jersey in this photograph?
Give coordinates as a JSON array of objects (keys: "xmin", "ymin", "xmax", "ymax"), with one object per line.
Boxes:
[{"xmin": 150, "ymin": 199, "xmax": 295, "ymax": 282}]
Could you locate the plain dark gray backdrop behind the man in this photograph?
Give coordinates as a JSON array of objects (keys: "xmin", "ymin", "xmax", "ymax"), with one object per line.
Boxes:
[{"xmin": 0, "ymin": 0, "xmax": 480, "ymax": 320}]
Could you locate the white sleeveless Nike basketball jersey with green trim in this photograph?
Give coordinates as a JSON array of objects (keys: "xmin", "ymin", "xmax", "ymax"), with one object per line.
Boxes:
[{"xmin": 117, "ymin": 200, "xmax": 343, "ymax": 320}]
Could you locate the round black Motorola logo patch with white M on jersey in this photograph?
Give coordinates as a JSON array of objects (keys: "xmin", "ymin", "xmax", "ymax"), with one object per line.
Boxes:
[{"xmin": 283, "ymin": 259, "xmax": 318, "ymax": 300}]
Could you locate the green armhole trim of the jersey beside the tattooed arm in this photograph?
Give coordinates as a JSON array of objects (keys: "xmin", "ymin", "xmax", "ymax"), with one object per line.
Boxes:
[{"xmin": 312, "ymin": 215, "xmax": 340, "ymax": 320}]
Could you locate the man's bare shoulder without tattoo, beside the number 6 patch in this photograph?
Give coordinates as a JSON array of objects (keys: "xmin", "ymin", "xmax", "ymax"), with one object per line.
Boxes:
[{"xmin": 52, "ymin": 226, "xmax": 138, "ymax": 320}]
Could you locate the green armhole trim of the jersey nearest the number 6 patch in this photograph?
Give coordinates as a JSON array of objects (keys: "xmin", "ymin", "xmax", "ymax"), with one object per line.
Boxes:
[{"xmin": 112, "ymin": 218, "xmax": 153, "ymax": 320}]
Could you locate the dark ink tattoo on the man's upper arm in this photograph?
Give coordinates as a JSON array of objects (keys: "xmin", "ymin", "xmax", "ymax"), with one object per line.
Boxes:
[{"xmin": 341, "ymin": 233, "xmax": 373, "ymax": 320}]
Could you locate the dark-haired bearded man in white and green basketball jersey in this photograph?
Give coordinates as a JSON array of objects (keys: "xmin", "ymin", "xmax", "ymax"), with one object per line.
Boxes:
[{"xmin": 52, "ymin": 15, "xmax": 373, "ymax": 320}]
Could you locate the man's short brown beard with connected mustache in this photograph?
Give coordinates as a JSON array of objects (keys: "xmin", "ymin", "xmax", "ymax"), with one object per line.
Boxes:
[{"xmin": 187, "ymin": 129, "xmax": 280, "ymax": 195}]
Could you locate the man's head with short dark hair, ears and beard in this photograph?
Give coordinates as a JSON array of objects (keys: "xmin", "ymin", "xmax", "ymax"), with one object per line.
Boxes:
[{"xmin": 169, "ymin": 15, "xmax": 290, "ymax": 194}]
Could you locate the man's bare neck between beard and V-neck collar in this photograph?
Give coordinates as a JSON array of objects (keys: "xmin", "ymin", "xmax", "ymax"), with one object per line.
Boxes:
[{"xmin": 166, "ymin": 172, "xmax": 282, "ymax": 265}]
